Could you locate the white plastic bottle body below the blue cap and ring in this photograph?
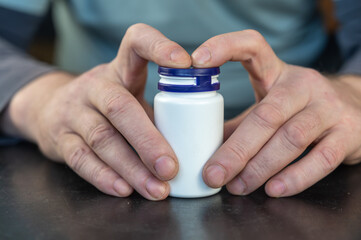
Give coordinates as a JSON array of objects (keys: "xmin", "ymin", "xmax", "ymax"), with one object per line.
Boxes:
[{"xmin": 154, "ymin": 91, "xmax": 224, "ymax": 198}]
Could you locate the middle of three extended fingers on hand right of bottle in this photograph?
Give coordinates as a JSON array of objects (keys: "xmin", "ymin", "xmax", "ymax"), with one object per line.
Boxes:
[{"xmin": 227, "ymin": 104, "xmax": 336, "ymax": 195}]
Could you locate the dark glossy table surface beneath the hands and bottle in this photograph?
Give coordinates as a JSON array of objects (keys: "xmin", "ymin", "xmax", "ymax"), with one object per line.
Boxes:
[{"xmin": 0, "ymin": 144, "xmax": 361, "ymax": 240}]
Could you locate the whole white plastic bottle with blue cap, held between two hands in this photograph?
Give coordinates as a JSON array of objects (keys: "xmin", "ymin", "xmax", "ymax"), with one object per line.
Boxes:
[{"xmin": 154, "ymin": 67, "xmax": 224, "ymax": 198}]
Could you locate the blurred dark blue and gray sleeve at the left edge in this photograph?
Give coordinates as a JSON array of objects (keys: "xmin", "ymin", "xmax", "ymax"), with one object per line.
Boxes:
[{"xmin": 0, "ymin": 6, "xmax": 54, "ymax": 113}]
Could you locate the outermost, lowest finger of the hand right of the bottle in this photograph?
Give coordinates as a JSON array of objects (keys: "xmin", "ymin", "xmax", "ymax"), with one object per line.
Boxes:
[{"xmin": 265, "ymin": 130, "xmax": 347, "ymax": 197}]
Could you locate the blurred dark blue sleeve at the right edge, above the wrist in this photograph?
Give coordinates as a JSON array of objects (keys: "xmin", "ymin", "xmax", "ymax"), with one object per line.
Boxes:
[{"xmin": 334, "ymin": 0, "xmax": 361, "ymax": 75}]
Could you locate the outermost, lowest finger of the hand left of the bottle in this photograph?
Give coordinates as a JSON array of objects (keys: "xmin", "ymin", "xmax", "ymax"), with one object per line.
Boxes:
[{"xmin": 59, "ymin": 134, "xmax": 133, "ymax": 197}]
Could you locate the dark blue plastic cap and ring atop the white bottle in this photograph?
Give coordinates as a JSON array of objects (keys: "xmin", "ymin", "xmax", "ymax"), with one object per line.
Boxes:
[{"xmin": 158, "ymin": 66, "xmax": 220, "ymax": 92}]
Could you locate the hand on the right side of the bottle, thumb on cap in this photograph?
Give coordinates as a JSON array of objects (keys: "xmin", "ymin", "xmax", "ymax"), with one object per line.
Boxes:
[{"xmin": 192, "ymin": 30, "xmax": 361, "ymax": 197}]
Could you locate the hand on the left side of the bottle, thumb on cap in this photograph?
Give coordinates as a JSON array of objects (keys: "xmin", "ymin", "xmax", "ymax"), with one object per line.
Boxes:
[{"xmin": 3, "ymin": 24, "xmax": 191, "ymax": 200}]
